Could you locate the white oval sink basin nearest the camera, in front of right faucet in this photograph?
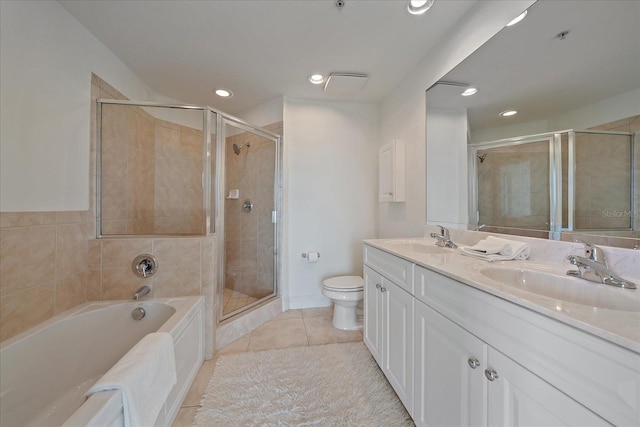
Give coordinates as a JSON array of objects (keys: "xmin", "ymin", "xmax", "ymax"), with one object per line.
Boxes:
[{"xmin": 480, "ymin": 267, "xmax": 640, "ymax": 312}]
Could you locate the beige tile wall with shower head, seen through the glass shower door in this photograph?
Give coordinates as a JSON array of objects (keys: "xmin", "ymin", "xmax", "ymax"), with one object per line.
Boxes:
[{"xmin": 225, "ymin": 122, "xmax": 282, "ymax": 298}]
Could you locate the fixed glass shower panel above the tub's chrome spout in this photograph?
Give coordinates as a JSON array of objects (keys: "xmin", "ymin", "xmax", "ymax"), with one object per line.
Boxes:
[{"xmin": 97, "ymin": 100, "xmax": 215, "ymax": 237}]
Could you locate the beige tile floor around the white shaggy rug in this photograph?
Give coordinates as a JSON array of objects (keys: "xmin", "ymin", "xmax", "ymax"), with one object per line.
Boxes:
[{"xmin": 173, "ymin": 307, "xmax": 362, "ymax": 427}]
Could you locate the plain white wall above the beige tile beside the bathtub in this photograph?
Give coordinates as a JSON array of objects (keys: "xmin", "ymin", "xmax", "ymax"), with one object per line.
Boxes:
[{"xmin": 0, "ymin": 0, "xmax": 168, "ymax": 211}]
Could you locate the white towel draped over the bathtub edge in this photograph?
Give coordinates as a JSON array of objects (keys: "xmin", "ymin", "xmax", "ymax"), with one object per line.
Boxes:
[{"xmin": 87, "ymin": 332, "xmax": 176, "ymax": 427}]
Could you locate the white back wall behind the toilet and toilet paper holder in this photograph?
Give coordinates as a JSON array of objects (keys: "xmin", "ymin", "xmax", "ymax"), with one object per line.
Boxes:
[{"xmin": 283, "ymin": 98, "xmax": 379, "ymax": 309}]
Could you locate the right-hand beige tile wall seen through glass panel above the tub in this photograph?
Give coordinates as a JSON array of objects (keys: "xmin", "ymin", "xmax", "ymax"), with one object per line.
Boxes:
[{"xmin": 151, "ymin": 119, "xmax": 202, "ymax": 234}]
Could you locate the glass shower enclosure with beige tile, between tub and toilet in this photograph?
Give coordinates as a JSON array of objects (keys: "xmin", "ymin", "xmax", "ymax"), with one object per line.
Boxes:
[{"xmin": 96, "ymin": 99, "xmax": 281, "ymax": 321}]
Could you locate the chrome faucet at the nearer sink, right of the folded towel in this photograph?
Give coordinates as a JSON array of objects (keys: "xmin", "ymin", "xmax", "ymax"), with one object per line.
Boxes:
[{"xmin": 567, "ymin": 242, "xmax": 636, "ymax": 289}]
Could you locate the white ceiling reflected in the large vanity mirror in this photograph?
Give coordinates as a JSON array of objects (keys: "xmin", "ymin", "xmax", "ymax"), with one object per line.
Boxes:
[{"xmin": 427, "ymin": 0, "xmax": 640, "ymax": 131}]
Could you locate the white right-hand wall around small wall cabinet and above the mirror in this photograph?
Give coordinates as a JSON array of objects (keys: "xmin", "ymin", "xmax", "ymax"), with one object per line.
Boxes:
[{"xmin": 378, "ymin": 0, "xmax": 534, "ymax": 237}]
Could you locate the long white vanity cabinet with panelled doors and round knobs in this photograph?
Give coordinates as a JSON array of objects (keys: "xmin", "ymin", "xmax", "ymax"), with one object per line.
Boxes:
[{"xmin": 364, "ymin": 245, "xmax": 640, "ymax": 427}]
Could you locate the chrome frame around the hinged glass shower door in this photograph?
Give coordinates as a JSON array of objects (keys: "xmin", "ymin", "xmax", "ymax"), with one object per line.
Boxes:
[{"xmin": 212, "ymin": 115, "xmax": 282, "ymax": 324}]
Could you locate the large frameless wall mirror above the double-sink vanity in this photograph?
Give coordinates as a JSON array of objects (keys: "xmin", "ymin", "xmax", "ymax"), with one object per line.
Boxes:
[{"xmin": 426, "ymin": 0, "xmax": 640, "ymax": 247}]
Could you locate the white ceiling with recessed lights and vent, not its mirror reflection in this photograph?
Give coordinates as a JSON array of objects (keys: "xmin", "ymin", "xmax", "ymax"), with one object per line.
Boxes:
[{"xmin": 60, "ymin": 0, "xmax": 477, "ymax": 114}]
